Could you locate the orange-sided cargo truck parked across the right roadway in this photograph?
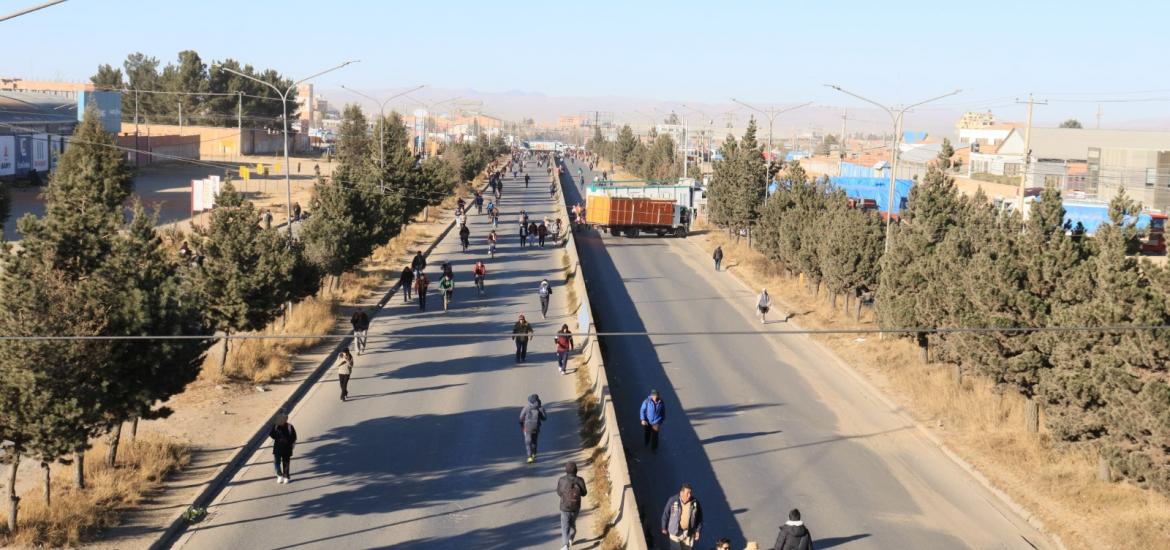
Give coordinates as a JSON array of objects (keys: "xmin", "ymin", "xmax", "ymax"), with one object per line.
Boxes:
[{"xmin": 585, "ymin": 194, "xmax": 690, "ymax": 236}]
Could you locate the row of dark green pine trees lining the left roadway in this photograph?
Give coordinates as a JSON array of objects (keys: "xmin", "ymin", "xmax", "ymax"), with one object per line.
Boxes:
[{"xmin": 0, "ymin": 106, "xmax": 507, "ymax": 529}]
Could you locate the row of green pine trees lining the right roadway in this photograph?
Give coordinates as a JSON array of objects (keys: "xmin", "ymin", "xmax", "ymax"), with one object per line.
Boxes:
[{"xmin": 709, "ymin": 123, "xmax": 1170, "ymax": 493}]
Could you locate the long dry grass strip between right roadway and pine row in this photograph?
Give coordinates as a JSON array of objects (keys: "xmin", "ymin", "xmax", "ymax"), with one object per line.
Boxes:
[{"xmin": 700, "ymin": 224, "xmax": 1170, "ymax": 549}]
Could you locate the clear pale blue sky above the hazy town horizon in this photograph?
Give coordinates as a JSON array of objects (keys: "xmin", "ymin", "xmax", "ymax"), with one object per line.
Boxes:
[{"xmin": 0, "ymin": 0, "xmax": 1170, "ymax": 122}]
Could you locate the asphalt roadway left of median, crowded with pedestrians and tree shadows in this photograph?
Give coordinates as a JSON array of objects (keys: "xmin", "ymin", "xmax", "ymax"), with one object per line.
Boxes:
[{"xmin": 177, "ymin": 156, "xmax": 597, "ymax": 549}]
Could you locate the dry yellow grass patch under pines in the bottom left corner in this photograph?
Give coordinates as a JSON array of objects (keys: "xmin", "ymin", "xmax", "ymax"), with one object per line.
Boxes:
[{"xmin": 0, "ymin": 436, "xmax": 191, "ymax": 548}]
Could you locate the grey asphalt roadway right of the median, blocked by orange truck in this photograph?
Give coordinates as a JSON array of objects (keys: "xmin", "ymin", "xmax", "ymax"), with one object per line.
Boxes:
[{"xmin": 556, "ymin": 155, "xmax": 1052, "ymax": 549}]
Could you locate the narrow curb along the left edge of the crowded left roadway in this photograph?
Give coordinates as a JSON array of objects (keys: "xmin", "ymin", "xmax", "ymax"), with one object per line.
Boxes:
[{"xmin": 149, "ymin": 187, "xmax": 470, "ymax": 550}]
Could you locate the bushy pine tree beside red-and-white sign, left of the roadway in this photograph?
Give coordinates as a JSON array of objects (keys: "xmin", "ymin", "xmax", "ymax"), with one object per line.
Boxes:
[{"xmin": 193, "ymin": 181, "xmax": 304, "ymax": 373}]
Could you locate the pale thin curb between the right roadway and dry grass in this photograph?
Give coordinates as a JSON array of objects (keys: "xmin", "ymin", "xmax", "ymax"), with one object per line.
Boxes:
[{"xmin": 693, "ymin": 235, "xmax": 1067, "ymax": 550}]
